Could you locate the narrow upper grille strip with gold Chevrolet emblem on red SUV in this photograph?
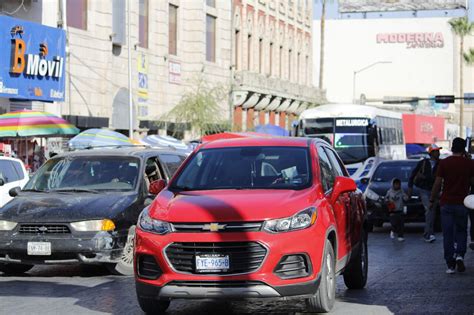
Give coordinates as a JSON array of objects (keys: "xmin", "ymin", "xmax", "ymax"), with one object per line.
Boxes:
[{"xmin": 172, "ymin": 222, "xmax": 263, "ymax": 233}]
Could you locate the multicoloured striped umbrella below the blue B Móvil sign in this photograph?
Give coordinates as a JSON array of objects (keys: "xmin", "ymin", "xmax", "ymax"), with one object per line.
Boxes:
[{"xmin": 0, "ymin": 110, "xmax": 79, "ymax": 138}]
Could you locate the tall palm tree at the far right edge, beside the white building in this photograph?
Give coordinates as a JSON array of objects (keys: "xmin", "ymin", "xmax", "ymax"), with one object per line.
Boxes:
[{"xmin": 449, "ymin": 17, "xmax": 474, "ymax": 137}]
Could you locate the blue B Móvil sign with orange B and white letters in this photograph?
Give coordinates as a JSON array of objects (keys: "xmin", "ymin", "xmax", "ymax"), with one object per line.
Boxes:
[{"xmin": 0, "ymin": 16, "xmax": 66, "ymax": 102}]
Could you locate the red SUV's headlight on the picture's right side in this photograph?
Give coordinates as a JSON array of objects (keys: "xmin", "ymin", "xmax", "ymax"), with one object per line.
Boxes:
[{"xmin": 263, "ymin": 207, "xmax": 318, "ymax": 233}]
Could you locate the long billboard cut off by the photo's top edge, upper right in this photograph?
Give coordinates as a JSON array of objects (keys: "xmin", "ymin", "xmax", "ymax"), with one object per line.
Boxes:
[{"xmin": 339, "ymin": 0, "xmax": 467, "ymax": 13}]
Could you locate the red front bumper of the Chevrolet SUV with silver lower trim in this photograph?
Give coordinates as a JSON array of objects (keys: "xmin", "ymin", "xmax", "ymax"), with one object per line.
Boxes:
[{"xmin": 135, "ymin": 226, "xmax": 326, "ymax": 299}]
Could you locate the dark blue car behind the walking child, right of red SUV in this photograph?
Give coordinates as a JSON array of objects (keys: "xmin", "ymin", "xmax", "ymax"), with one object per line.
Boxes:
[{"xmin": 364, "ymin": 159, "xmax": 441, "ymax": 231}]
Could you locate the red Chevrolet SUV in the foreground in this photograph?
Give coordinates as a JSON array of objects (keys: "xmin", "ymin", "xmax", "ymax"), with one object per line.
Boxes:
[{"xmin": 135, "ymin": 138, "xmax": 368, "ymax": 313}]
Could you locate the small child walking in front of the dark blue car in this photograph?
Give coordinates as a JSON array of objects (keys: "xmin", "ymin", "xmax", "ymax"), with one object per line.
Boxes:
[{"xmin": 385, "ymin": 178, "xmax": 408, "ymax": 242}]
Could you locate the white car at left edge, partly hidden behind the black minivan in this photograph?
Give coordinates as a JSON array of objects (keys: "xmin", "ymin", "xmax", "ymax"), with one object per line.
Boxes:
[{"xmin": 0, "ymin": 156, "xmax": 29, "ymax": 207}]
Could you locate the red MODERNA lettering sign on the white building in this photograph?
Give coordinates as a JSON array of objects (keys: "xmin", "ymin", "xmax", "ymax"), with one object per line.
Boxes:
[{"xmin": 377, "ymin": 32, "xmax": 444, "ymax": 49}]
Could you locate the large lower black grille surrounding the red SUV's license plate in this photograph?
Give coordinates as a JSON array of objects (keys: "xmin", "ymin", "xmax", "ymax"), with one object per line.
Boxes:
[{"xmin": 166, "ymin": 242, "xmax": 267, "ymax": 274}]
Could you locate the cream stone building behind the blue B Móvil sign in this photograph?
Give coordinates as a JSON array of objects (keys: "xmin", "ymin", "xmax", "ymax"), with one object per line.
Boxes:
[{"xmin": 0, "ymin": 0, "xmax": 232, "ymax": 137}]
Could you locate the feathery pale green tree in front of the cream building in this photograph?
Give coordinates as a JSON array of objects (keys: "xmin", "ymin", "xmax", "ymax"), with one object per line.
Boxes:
[{"xmin": 164, "ymin": 76, "xmax": 228, "ymax": 137}]
